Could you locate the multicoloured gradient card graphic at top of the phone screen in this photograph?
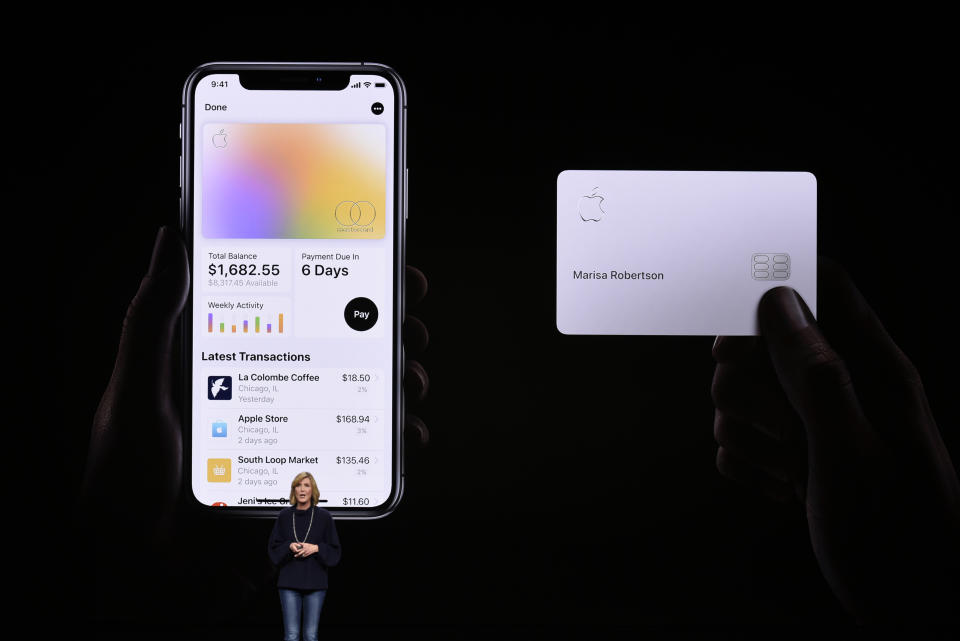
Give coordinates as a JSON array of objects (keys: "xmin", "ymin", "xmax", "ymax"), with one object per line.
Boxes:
[{"xmin": 201, "ymin": 122, "xmax": 386, "ymax": 240}]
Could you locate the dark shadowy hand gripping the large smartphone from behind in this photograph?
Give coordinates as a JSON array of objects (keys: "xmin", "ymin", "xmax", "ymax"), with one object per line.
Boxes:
[{"xmin": 75, "ymin": 227, "xmax": 429, "ymax": 536}]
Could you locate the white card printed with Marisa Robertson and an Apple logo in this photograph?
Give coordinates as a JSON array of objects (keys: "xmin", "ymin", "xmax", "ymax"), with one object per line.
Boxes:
[{"xmin": 557, "ymin": 170, "xmax": 817, "ymax": 336}]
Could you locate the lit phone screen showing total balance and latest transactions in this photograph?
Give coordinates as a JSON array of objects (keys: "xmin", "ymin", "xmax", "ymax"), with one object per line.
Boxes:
[{"xmin": 184, "ymin": 69, "xmax": 402, "ymax": 515}]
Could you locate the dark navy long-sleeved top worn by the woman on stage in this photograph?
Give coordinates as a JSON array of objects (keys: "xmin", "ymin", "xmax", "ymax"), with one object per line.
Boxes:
[{"xmin": 267, "ymin": 506, "xmax": 340, "ymax": 590}]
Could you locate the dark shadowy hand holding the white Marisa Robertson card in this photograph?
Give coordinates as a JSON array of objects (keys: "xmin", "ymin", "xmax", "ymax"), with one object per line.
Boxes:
[{"xmin": 713, "ymin": 259, "xmax": 960, "ymax": 623}]
